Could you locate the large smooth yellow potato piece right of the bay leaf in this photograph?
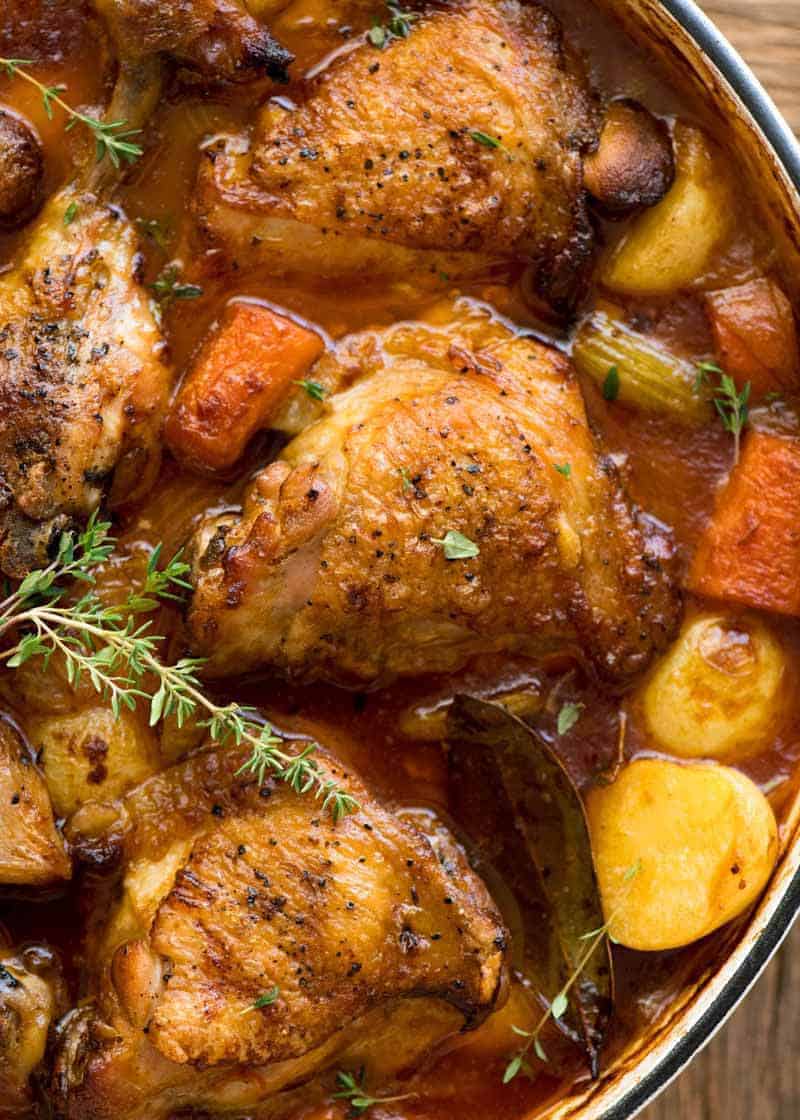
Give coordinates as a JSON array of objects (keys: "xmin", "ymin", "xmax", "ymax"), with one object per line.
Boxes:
[{"xmin": 587, "ymin": 758, "xmax": 778, "ymax": 950}]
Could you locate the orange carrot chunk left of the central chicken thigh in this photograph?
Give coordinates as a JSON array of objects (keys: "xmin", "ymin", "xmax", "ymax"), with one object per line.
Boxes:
[{"xmin": 165, "ymin": 302, "xmax": 324, "ymax": 470}]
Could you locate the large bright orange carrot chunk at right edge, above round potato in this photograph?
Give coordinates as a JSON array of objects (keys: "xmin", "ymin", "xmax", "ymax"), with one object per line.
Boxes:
[{"xmin": 688, "ymin": 430, "xmax": 800, "ymax": 615}]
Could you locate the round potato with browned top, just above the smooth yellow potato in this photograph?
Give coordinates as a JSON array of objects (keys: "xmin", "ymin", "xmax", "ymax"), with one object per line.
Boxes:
[{"xmin": 643, "ymin": 614, "xmax": 785, "ymax": 760}]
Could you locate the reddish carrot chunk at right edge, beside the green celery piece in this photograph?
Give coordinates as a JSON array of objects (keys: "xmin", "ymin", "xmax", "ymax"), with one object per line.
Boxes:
[{"xmin": 706, "ymin": 277, "xmax": 800, "ymax": 398}]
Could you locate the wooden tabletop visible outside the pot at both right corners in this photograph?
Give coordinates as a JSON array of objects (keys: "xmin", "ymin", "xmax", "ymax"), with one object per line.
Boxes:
[{"xmin": 642, "ymin": 0, "xmax": 800, "ymax": 1120}]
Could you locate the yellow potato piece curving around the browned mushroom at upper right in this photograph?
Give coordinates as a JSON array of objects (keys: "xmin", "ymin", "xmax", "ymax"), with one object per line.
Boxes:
[{"xmin": 601, "ymin": 125, "xmax": 732, "ymax": 296}]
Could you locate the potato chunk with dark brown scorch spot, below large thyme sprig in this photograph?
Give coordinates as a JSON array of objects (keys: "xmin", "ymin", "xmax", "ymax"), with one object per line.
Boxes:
[{"xmin": 26, "ymin": 704, "xmax": 160, "ymax": 816}]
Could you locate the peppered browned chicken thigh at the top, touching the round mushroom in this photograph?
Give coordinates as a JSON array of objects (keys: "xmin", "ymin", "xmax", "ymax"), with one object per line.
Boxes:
[{"xmin": 191, "ymin": 0, "xmax": 596, "ymax": 307}]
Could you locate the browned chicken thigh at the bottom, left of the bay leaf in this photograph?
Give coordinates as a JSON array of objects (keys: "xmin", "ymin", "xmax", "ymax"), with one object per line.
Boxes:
[{"xmin": 54, "ymin": 748, "xmax": 506, "ymax": 1120}]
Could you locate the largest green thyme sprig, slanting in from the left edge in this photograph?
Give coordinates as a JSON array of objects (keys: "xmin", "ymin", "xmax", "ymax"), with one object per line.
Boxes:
[{"xmin": 0, "ymin": 515, "xmax": 357, "ymax": 821}]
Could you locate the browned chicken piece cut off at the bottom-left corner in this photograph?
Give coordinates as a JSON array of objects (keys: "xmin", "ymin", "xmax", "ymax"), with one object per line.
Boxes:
[{"xmin": 0, "ymin": 940, "xmax": 66, "ymax": 1120}]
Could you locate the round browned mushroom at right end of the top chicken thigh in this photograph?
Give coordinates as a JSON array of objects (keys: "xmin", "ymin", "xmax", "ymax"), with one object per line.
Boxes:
[{"xmin": 584, "ymin": 100, "xmax": 675, "ymax": 218}]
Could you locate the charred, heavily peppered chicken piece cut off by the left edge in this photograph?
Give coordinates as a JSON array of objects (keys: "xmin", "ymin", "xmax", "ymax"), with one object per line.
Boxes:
[{"xmin": 0, "ymin": 188, "xmax": 170, "ymax": 577}]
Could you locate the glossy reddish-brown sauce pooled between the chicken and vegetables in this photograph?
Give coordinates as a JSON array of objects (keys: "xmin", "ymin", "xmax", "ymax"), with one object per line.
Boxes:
[{"xmin": 0, "ymin": 0, "xmax": 800, "ymax": 1120}]
